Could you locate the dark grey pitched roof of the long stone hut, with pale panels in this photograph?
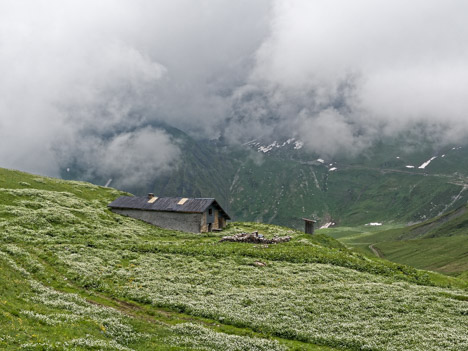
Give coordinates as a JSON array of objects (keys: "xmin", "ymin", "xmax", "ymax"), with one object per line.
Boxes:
[{"xmin": 107, "ymin": 196, "xmax": 231, "ymax": 219}]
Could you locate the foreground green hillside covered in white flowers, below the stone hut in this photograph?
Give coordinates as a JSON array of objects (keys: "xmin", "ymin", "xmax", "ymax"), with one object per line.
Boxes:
[{"xmin": 0, "ymin": 169, "xmax": 468, "ymax": 350}]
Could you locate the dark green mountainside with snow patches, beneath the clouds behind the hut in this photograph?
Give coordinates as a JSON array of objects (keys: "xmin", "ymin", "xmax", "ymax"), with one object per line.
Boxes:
[{"xmin": 64, "ymin": 127, "xmax": 468, "ymax": 228}]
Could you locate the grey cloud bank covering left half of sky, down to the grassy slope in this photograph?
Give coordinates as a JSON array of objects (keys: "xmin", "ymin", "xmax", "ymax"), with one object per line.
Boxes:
[{"xmin": 0, "ymin": 0, "xmax": 267, "ymax": 187}]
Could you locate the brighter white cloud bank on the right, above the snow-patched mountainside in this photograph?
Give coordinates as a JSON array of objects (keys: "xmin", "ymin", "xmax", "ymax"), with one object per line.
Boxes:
[{"xmin": 234, "ymin": 0, "xmax": 468, "ymax": 154}]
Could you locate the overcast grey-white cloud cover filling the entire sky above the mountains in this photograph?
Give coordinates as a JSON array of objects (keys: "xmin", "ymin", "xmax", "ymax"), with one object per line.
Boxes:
[{"xmin": 0, "ymin": 0, "xmax": 468, "ymax": 182}]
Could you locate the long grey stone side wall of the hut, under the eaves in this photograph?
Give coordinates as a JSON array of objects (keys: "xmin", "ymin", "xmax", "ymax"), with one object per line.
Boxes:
[{"xmin": 112, "ymin": 208, "xmax": 202, "ymax": 233}]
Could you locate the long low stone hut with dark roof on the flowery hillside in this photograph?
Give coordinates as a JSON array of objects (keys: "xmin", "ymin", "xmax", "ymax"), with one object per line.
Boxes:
[{"xmin": 108, "ymin": 194, "xmax": 231, "ymax": 233}]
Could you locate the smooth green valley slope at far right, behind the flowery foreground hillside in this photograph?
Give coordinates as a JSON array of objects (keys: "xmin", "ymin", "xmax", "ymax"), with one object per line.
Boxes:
[{"xmin": 323, "ymin": 206, "xmax": 468, "ymax": 276}]
